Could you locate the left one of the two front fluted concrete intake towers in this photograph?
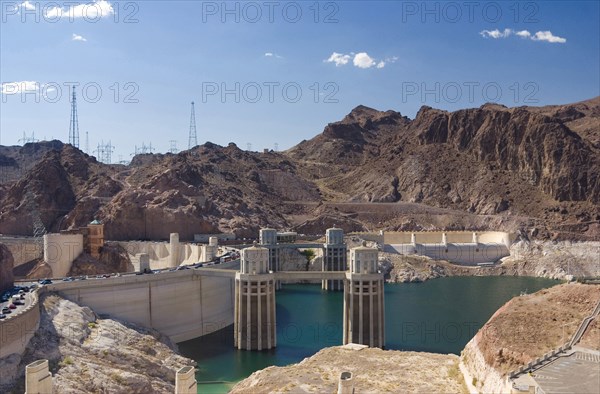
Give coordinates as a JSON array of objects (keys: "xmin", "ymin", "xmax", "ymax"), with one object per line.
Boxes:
[{"xmin": 233, "ymin": 245, "xmax": 277, "ymax": 350}]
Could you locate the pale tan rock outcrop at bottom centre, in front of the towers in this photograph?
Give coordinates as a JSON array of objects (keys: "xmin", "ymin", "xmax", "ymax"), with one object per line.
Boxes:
[{"xmin": 230, "ymin": 346, "xmax": 466, "ymax": 394}]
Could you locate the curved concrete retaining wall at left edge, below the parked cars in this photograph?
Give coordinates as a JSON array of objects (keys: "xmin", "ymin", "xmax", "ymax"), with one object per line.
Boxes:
[{"xmin": 0, "ymin": 289, "xmax": 44, "ymax": 358}]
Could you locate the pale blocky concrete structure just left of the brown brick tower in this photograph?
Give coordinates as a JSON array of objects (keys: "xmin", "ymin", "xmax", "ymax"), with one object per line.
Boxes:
[{"xmin": 44, "ymin": 234, "xmax": 83, "ymax": 277}]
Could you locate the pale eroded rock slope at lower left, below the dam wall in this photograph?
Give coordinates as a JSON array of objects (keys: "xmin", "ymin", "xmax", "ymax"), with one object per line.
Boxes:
[{"xmin": 2, "ymin": 294, "xmax": 195, "ymax": 393}]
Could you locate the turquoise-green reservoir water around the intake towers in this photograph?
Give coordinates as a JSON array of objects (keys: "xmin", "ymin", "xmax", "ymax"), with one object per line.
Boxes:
[{"xmin": 179, "ymin": 277, "xmax": 559, "ymax": 393}]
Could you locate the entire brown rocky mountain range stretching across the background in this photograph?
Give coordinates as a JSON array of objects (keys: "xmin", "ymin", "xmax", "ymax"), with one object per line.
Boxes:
[{"xmin": 0, "ymin": 97, "xmax": 600, "ymax": 240}]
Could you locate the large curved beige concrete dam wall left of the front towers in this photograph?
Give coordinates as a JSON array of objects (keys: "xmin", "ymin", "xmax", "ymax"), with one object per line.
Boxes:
[{"xmin": 47, "ymin": 270, "xmax": 235, "ymax": 342}]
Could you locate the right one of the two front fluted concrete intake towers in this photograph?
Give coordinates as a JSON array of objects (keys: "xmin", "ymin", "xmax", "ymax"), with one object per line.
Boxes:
[{"xmin": 344, "ymin": 246, "xmax": 385, "ymax": 348}]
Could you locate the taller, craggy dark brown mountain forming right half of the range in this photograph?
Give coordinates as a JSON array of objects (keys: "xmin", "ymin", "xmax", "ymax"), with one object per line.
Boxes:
[{"xmin": 286, "ymin": 98, "xmax": 600, "ymax": 234}]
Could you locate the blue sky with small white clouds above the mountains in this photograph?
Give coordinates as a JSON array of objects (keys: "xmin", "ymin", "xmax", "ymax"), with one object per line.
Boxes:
[{"xmin": 0, "ymin": 0, "xmax": 600, "ymax": 163}]
